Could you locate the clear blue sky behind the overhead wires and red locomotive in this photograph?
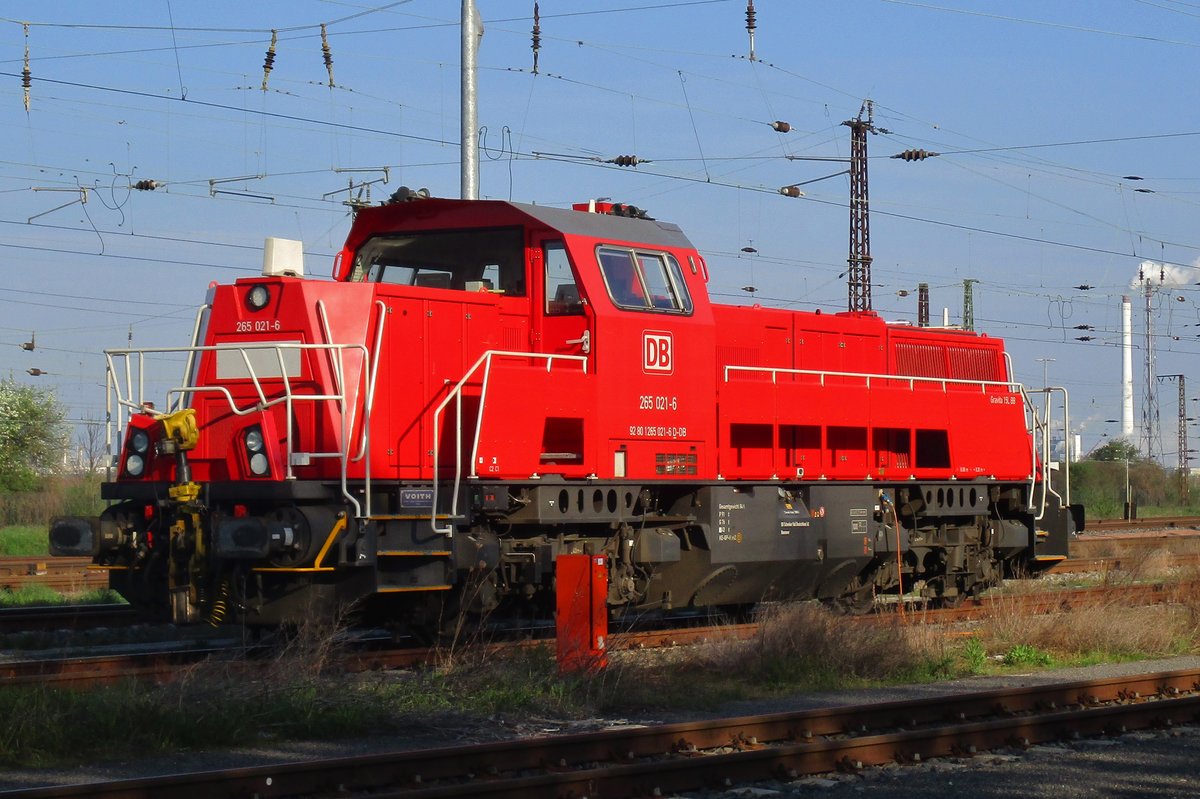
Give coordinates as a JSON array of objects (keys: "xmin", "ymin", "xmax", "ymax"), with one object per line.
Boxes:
[{"xmin": 0, "ymin": 0, "xmax": 1200, "ymax": 463}]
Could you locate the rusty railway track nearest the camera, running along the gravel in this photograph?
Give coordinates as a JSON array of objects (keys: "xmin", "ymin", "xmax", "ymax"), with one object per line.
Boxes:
[{"xmin": 9, "ymin": 671, "xmax": 1200, "ymax": 799}]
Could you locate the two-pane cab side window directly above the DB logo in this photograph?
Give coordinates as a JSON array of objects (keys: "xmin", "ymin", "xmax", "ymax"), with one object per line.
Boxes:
[{"xmin": 596, "ymin": 247, "xmax": 692, "ymax": 313}]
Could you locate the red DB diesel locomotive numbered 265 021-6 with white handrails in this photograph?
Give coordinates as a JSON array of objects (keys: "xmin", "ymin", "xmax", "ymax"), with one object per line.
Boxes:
[{"xmin": 50, "ymin": 194, "xmax": 1082, "ymax": 625}]
